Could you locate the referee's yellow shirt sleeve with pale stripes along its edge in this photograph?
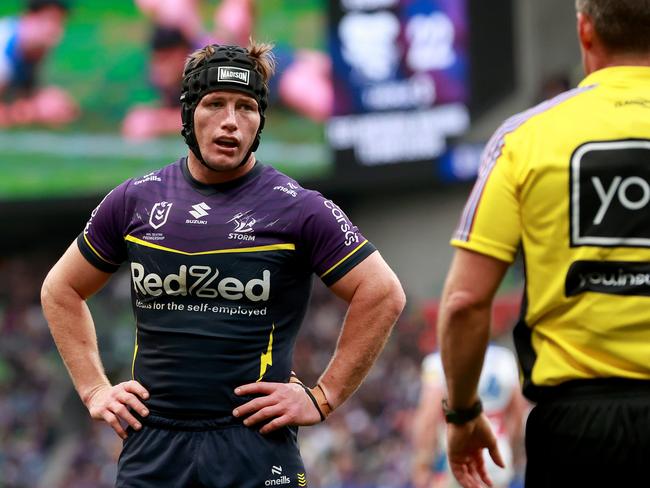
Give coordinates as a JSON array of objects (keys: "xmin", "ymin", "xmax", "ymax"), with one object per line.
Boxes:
[{"xmin": 451, "ymin": 122, "xmax": 521, "ymax": 263}]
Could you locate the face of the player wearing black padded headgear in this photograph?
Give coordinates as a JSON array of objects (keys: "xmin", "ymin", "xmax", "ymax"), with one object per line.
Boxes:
[{"xmin": 194, "ymin": 91, "xmax": 260, "ymax": 171}]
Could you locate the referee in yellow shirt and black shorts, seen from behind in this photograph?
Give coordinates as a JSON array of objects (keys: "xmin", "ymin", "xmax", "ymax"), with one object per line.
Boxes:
[{"xmin": 432, "ymin": 0, "xmax": 650, "ymax": 488}]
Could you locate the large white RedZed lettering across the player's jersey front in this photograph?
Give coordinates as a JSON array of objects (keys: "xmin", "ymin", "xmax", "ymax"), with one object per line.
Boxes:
[{"xmin": 131, "ymin": 263, "xmax": 271, "ymax": 302}]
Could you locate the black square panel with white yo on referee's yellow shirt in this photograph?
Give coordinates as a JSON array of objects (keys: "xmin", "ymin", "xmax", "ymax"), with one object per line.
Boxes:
[{"xmin": 570, "ymin": 140, "xmax": 650, "ymax": 247}]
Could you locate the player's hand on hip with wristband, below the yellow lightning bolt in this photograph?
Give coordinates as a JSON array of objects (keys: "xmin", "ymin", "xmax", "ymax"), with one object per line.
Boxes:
[{"xmin": 233, "ymin": 382, "xmax": 321, "ymax": 434}]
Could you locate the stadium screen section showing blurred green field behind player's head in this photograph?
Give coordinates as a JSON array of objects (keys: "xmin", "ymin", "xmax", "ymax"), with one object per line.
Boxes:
[{"xmin": 0, "ymin": 0, "xmax": 332, "ymax": 201}]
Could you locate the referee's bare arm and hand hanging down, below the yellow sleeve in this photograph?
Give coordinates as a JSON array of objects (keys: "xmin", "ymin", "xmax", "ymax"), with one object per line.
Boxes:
[{"xmin": 438, "ymin": 249, "xmax": 508, "ymax": 488}]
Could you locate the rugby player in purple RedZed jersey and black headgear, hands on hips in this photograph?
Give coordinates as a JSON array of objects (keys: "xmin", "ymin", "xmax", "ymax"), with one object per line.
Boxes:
[{"xmin": 42, "ymin": 43, "xmax": 405, "ymax": 488}]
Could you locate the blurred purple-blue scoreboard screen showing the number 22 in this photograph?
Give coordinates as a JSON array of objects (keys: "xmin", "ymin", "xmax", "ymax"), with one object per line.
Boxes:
[{"xmin": 328, "ymin": 0, "xmax": 469, "ymax": 166}]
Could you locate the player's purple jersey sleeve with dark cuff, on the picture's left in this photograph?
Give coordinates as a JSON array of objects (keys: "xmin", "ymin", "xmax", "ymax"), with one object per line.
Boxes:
[{"xmin": 77, "ymin": 182, "xmax": 128, "ymax": 273}]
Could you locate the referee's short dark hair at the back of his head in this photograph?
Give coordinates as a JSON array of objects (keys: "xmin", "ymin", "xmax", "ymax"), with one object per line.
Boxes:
[{"xmin": 576, "ymin": 0, "xmax": 650, "ymax": 54}]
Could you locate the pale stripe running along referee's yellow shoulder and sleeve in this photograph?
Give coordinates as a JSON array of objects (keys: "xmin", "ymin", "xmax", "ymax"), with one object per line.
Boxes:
[{"xmin": 454, "ymin": 85, "xmax": 594, "ymax": 241}]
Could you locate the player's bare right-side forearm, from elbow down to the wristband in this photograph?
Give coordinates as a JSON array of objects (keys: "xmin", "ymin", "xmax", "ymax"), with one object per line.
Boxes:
[{"xmin": 319, "ymin": 279, "xmax": 405, "ymax": 408}]
